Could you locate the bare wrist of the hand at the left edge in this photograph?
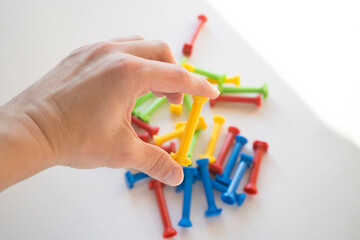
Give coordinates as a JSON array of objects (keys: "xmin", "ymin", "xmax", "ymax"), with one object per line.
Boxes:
[{"xmin": 0, "ymin": 106, "xmax": 54, "ymax": 192}]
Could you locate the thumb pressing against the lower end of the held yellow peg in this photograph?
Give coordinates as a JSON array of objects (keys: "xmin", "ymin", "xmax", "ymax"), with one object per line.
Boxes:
[{"xmin": 133, "ymin": 139, "xmax": 184, "ymax": 186}]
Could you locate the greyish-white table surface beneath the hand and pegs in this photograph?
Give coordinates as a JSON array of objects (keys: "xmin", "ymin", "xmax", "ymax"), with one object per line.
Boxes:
[{"xmin": 0, "ymin": 0, "xmax": 360, "ymax": 240}]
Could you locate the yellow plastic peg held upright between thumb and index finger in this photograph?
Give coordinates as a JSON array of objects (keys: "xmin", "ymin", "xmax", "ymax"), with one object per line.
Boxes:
[{"xmin": 170, "ymin": 95, "xmax": 209, "ymax": 167}]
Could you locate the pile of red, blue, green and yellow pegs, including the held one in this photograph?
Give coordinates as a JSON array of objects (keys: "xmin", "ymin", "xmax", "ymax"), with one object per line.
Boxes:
[{"xmin": 125, "ymin": 15, "xmax": 268, "ymax": 238}]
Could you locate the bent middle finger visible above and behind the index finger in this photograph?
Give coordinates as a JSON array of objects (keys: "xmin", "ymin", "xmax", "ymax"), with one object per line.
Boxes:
[{"xmin": 114, "ymin": 40, "xmax": 177, "ymax": 63}]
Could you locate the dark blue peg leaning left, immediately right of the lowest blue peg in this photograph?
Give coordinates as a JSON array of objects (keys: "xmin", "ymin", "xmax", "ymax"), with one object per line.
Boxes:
[{"xmin": 196, "ymin": 158, "xmax": 222, "ymax": 217}]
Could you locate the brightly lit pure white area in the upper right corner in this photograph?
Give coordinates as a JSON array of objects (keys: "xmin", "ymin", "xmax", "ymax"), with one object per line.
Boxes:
[{"xmin": 208, "ymin": 0, "xmax": 360, "ymax": 146}]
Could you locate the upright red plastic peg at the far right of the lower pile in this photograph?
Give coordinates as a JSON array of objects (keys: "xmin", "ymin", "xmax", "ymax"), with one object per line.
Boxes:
[{"xmin": 244, "ymin": 141, "xmax": 269, "ymax": 194}]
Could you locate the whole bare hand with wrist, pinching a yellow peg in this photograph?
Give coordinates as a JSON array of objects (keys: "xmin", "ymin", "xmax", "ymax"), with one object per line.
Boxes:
[{"xmin": 0, "ymin": 36, "xmax": 219, "ymax": 191}]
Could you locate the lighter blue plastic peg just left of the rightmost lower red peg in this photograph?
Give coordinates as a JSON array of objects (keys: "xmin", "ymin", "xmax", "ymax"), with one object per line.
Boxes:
[{"xmin": 220, "ymin": 153, "xmax": 253, "ymax": 205}]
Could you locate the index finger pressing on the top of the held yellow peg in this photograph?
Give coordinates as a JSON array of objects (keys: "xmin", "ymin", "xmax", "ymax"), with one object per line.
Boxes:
[{"xmin": 133, "ymin": 59, "xmax": 220, "ymax": 101}]
